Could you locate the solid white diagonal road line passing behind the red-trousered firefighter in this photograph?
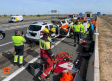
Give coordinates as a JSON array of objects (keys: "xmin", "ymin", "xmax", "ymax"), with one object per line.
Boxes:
[{"xmin": 2, "ymin": 37, "xmax": 66, "ymax": 81}]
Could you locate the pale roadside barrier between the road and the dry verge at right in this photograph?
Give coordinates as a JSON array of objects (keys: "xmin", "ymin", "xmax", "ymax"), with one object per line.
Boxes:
[{"xmin": 86, "ymin": 16, "xmax": 100, "ymax": 81}]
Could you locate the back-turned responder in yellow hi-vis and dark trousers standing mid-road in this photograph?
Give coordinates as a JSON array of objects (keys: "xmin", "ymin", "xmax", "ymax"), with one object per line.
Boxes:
[{"xmin": 73, "ymin": 22, "xmax": 81, "ymax": 47}]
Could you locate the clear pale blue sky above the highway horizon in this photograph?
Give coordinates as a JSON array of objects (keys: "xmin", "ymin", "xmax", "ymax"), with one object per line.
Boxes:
[{"xmin": 0, "ymin": 0, "xmax": 112, "ymax": 15}]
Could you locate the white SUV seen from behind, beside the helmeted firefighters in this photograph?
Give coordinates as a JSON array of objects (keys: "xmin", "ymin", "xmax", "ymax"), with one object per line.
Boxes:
[{"xmin": 26, "ymin": 22, "xmax": 58, "ymax": 41}]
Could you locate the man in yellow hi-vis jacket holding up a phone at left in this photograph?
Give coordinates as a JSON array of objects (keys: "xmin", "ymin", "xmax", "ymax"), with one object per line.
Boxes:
[{"xmin": 12, "ymin": 30, "xmax": 26, "ymax": 67}]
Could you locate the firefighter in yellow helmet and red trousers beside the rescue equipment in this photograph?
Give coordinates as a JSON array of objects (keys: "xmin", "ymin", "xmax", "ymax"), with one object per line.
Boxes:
[{"xmin": 38, "ymin": 28, "xmax": 55, "ymax": 81}]
